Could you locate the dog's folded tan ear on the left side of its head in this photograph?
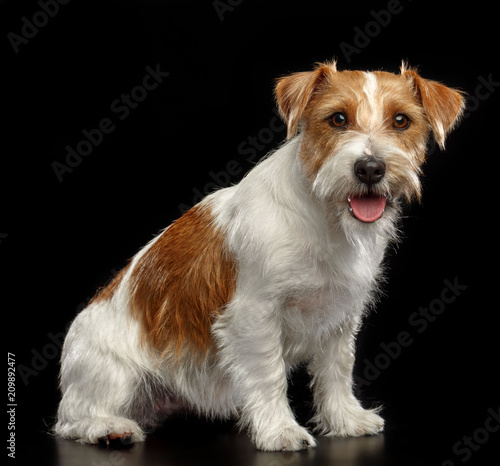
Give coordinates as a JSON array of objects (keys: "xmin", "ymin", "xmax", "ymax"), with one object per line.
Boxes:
[{"xmin": 274, "ymin": 61, "xmax": 337, "ymax": 139}]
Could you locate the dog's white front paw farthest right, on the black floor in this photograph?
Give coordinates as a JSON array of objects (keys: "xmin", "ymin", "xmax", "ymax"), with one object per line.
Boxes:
[{"xmin": 318, "ymin": 406, "xmax": 384, "ymax": 437}]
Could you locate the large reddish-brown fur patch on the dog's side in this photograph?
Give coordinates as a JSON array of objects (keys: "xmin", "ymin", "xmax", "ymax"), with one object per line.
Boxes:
[{"xmin": 130, "ymin": 205, "xmax": 236, "ymax": 357}]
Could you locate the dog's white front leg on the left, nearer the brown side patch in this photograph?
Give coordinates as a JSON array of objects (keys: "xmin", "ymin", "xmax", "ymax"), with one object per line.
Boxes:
[{"xmin": 214, "ymin": 297, "xmax": 316, "ymax": 451}]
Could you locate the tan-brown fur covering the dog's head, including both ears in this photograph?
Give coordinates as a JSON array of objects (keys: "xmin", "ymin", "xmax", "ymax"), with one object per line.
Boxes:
[{"xmin": 275, "ymin": 63, "xmax": 464, "ymax": 184}]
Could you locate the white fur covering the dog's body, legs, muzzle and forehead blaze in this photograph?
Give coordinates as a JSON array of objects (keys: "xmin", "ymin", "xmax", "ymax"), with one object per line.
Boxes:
[{"xmin": 55, "ymin": 67, "xmax": 442, "ymax": 450}]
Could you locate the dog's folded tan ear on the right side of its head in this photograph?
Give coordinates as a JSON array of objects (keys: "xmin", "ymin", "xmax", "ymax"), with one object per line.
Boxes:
[{"xmin": 401, "ymin": 64, "xmax": 465, "ymax": 149}]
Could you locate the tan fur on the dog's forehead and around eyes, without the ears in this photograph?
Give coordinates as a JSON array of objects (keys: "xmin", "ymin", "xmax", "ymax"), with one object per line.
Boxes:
[{"xmin": 301, "ymin": 71, "xmax": 428, "ymax": 179}]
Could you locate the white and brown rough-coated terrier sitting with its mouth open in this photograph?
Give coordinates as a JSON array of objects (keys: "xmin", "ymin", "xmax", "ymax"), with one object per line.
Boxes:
[{"xmin": 54, "ymin": 61, "xmax": 464, "ymax": 451}]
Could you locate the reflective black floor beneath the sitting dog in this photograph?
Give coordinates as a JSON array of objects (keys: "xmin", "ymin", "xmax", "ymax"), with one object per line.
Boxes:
[{"xmin": 21, "ymin": 419, "xmax": 498, "ymax": 466}]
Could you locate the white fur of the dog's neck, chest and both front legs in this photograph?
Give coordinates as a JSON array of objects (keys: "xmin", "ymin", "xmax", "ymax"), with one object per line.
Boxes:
[{"xmin": 207, "ymin": 137, "xmax": 388, "ymax": 450}]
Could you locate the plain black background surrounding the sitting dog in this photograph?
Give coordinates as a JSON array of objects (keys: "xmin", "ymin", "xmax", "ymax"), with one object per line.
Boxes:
[{"xmin": 0, "ymin": 0, "xmax": 500, "ymax": 464}]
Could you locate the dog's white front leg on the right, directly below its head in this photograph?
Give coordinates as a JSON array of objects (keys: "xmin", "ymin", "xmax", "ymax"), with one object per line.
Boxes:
[{"xmin": 309, "ymin": 317, "xmax": 384, "ymax": 437}]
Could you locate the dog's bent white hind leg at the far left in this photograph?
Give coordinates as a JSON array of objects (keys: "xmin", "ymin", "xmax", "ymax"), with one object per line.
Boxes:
[{"xmin": 54, "ymin": 301, "xmax": 150, "ymax": 444}]
